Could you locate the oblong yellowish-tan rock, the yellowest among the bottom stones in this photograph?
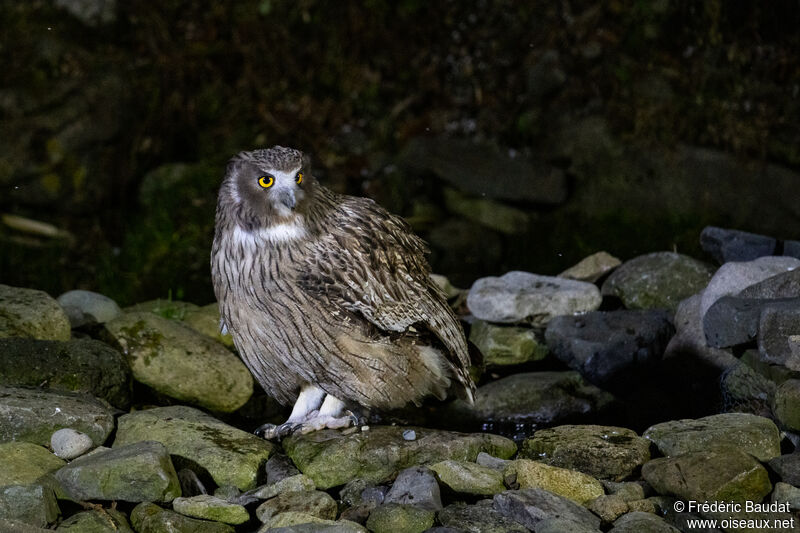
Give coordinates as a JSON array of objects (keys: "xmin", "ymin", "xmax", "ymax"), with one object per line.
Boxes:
[{"xmin": 504, "ymin": 459, "xmax": 605, "ymax": 505}]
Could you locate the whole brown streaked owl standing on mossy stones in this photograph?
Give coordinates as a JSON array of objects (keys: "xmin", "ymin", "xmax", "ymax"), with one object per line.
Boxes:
[{"xmin": 211, "ymin": 146, "xmax": 475, "ymax": 438}]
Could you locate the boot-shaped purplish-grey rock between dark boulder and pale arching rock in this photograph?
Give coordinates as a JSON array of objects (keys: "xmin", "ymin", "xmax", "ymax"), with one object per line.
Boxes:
[{"xmin": 664, "ymin": 292, "xmax": 739, "ymax": 374}]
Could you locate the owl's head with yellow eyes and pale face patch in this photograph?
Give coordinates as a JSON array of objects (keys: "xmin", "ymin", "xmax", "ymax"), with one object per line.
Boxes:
[{"xmin": 220, "ymin": 146, "xmax": 315, "ymax": 229}]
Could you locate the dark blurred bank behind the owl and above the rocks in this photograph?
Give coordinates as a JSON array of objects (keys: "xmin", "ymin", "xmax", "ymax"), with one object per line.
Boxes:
[{"xmin": 0, "ymin": 0, "xmax": 800, "ymax": 304}]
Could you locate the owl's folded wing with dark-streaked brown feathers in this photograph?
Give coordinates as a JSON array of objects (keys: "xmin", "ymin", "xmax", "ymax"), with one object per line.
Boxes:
[{"xmin": 298, "ymin": 197, "xmax": 470, "ymax": 376}]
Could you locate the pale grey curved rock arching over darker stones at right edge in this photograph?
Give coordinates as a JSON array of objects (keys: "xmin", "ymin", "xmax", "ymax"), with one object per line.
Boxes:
[{"xmin": 700, "ymin": 256, "xmax": 800, "ymax": 317}]
